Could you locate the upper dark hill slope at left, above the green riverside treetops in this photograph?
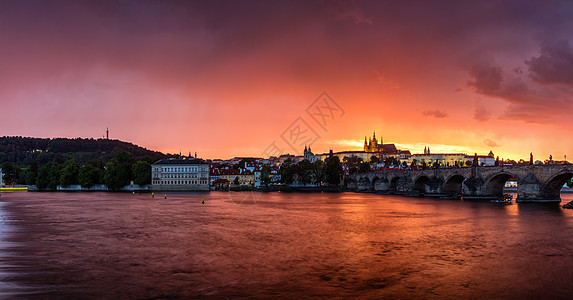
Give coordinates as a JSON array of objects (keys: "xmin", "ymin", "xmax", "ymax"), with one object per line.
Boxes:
[{"xmin": 0, "ymin": 136, "xmax": 166, "ymax": 165}]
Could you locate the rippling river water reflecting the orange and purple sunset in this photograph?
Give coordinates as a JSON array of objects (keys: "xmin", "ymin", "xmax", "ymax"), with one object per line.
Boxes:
[{"xmin": 0, "ymin": 192, "xmax": 573, "ymax": 299}]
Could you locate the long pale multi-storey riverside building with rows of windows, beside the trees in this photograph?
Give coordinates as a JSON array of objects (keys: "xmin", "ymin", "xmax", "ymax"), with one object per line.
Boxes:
[{"xmin": 151, "ymin": 157, "xmax": 209, "ymax": 191}]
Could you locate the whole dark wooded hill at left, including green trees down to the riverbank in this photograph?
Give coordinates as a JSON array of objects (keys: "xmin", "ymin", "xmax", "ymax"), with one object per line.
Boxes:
[{"xmin": 0, "ymin": 137, "xmax": 167, "ymax": 190}]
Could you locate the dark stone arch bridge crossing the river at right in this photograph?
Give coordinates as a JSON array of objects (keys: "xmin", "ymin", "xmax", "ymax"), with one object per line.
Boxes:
[{"xmin": 345, "ymin": 164, "xmax": 573, "ymax": 202}]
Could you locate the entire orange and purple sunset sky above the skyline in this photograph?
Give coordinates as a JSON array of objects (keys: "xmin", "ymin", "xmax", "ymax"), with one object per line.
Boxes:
[{"xmin": 0, "ymin": 0, "xmax": 573, "ymax": 161}]
